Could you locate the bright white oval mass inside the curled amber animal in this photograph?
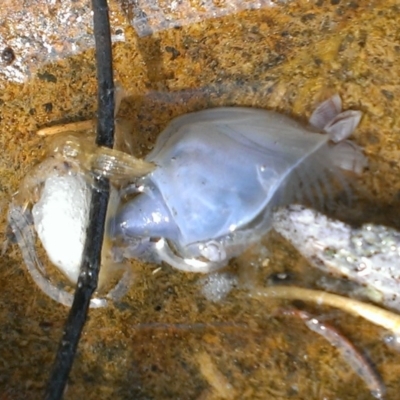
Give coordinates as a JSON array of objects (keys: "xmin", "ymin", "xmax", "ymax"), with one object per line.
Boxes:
[{"xmin": 32, "ymin": 174, "xmax": 91, "ymax": 283}]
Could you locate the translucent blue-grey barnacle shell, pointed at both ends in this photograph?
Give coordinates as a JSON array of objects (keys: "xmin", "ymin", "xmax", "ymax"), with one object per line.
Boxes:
[{"xmin": 114, "ymin": 108, "xmax": 333, "ymax": 247}]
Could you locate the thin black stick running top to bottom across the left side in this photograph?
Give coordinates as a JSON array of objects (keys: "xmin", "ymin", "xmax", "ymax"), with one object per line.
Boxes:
[{"xmin": 45, "ymin": 0, "xmax": 114, "ymax": 400}]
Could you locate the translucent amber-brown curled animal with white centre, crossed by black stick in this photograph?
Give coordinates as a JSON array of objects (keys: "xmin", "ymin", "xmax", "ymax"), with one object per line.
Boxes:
[{"xmin": 8, "ymin": 124, "xmax": 153, "ymax": 307}]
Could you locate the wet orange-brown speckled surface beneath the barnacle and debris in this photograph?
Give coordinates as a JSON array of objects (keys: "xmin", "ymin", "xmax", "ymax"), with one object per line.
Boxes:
[{"xmin": 0, "ymin": 0, "xmax": 400, "ymax": 400}]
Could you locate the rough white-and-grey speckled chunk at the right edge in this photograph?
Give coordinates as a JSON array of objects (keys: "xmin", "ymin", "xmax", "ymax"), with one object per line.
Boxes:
[{"xmin": 273, "ymin": 205, "xmax": 400, "ymax": 310}]
